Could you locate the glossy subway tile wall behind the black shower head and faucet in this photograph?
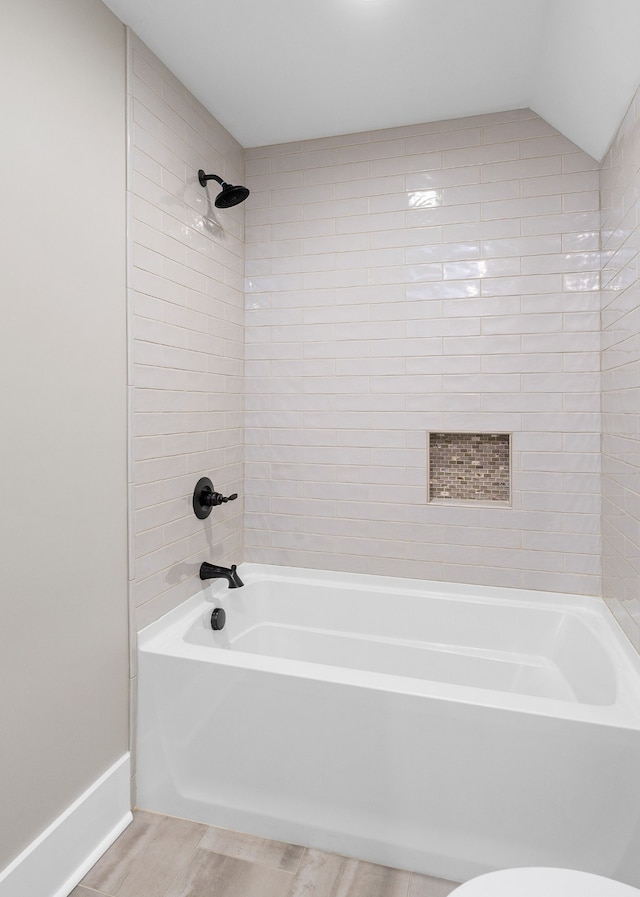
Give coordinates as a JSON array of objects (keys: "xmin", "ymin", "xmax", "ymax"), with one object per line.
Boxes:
[{"xmin": 128, "ymin": 32, "xmax": 244, "ymax": 632}]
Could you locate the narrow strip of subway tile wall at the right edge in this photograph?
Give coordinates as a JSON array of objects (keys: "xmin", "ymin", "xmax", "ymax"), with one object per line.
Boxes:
[{"xmin": 601, "ymin": 84, "xmax": 640, "ymax": 651}]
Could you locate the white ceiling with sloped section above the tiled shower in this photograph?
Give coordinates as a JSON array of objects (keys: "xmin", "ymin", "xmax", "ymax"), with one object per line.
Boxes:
[{"xmin": 100, "ymin": 0, "xmax": 640, "ymax": 160}]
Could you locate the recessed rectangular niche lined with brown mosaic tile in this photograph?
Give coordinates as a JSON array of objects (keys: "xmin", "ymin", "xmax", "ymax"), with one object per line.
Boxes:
[{"xmin": 427, "ymin": 433, "xmax": 511, "ymax": 505}]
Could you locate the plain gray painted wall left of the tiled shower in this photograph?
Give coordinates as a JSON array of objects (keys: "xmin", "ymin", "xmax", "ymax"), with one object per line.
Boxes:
[{"xmin": 0, "ymin": 0, "xmax": 128, "ymax": 868}]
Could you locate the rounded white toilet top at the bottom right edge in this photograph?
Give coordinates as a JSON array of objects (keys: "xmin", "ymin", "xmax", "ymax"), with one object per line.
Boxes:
[{"xmin": 450, "ymin": 867, "xmax": 640, "ymax": 897}]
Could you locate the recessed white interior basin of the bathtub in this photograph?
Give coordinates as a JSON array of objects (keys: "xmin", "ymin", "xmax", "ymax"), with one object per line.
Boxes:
[{"xmin": 175, "ymin": 565, "xmax": 640, "ymax": 706}]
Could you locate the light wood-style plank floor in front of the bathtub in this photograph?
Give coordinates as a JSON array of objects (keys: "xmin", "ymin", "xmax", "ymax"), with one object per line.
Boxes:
[{"xmin": 70, "ymin": 810, "xmax": 456, "ymax": 897}]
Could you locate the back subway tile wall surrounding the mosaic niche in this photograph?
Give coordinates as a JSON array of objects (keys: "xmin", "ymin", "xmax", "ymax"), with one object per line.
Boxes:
[{"xmin": 245, "ymin": 110, "xmax": 601, "ymax": 594}]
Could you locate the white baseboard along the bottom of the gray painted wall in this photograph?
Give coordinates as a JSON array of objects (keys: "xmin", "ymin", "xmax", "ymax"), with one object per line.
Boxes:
[{"xmin": 0, "ymin": 753, "xmax": 133, "ymax": 897}]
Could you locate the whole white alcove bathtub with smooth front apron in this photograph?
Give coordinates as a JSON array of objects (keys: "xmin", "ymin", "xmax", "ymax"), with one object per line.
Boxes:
[{"xmin": 137, "ymin": 564, "xmax": 640, "ymax": 886}]
